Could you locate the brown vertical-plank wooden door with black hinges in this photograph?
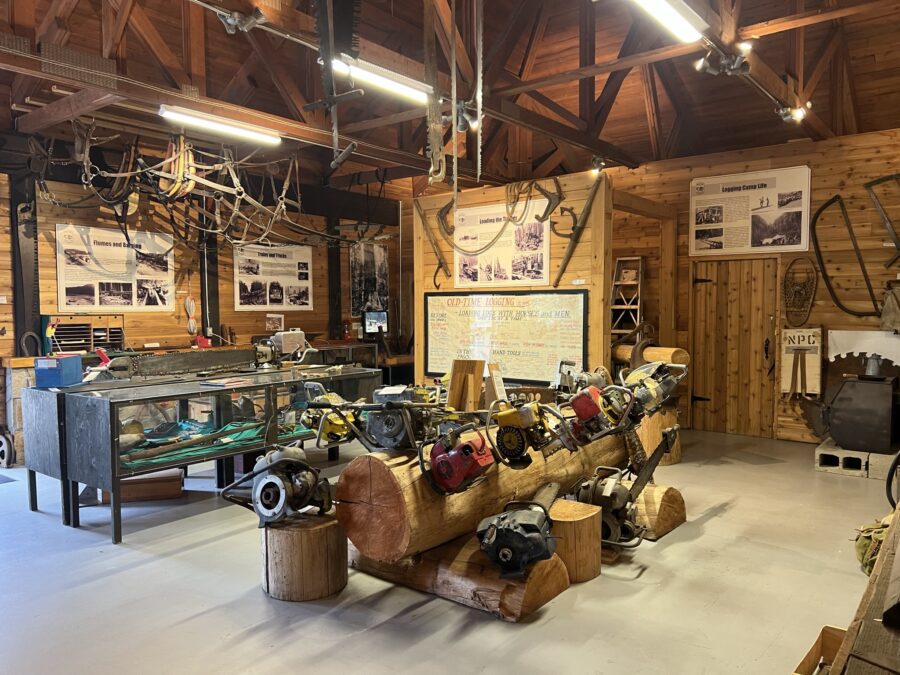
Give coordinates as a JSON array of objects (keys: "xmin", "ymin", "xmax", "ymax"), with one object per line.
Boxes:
[{"xmin": 691, "ymin": 258, "xmax": 778, "ymax": 438}]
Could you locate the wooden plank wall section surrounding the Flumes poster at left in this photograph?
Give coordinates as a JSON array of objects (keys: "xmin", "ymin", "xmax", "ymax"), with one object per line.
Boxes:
[{"xmin": 36, "ymin": 182, "xmax": 202, "ymax": 349}]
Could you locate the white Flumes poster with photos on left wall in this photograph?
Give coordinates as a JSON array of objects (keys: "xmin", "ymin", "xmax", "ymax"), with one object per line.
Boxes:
[{"xmin": 56, "ymin": 224, "xmax": 175, "ymax": 314}]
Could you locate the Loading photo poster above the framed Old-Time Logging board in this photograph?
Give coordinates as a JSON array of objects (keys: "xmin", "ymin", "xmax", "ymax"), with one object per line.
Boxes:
[{"xmin": 453, "ymin": 199, "xmax": 550, "ymax": 288}]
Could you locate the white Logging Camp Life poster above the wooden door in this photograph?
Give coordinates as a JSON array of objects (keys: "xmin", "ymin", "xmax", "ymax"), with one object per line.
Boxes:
[{"xmin": 689, "ymin": 166, "xmax": 810, "ymax": 255}]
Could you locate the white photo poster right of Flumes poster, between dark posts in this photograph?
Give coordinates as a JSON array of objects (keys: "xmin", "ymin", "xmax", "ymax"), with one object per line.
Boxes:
[{"xmin": 234, "ymin": 245, "xmax": 313, "ymax": 312}]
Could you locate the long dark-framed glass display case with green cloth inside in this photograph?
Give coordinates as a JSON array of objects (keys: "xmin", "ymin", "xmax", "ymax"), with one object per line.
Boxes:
[{"xmin": 26, "ymin": 367, "xmax": 382, "ymax": 543}]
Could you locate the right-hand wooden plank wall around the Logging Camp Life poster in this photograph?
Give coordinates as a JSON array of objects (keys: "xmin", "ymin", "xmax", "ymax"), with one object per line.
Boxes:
[{"xmin": 608, "ymin": 130, "xmax": 900, "ymax": 441}]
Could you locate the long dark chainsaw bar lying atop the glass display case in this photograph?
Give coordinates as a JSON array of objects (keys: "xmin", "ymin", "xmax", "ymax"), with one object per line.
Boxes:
[{"xmin": 107, "ymin": 348, "xmax": 256, "ymax": 379}]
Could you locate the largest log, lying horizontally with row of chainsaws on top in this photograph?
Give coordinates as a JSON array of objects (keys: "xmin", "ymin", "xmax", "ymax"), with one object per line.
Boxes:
[{"xmin": 336, "ymin": 436, "xmax": 628, "ymax": 562}]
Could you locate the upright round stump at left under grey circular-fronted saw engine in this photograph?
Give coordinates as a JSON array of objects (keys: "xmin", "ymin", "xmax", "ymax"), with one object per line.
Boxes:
[{"xmin": 260, "ymin": 515, "xmax": 347, "ymax": 602}]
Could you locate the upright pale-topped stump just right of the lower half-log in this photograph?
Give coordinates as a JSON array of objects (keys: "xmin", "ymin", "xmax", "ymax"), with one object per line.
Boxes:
[{"xmin": 550, "ymin": 499, "xmax": 601, "ymax": 584}]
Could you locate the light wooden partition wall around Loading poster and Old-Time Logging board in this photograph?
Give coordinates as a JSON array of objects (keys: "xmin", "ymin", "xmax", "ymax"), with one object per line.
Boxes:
[{"xmin": 415, "ymin": 173, "xmax": 620, "ymax": 382}]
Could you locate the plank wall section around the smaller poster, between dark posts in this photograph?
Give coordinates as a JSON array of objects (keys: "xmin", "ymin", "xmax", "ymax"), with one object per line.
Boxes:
[{"xmin": 215, "ymin": 215, "xmax": 332, "ymax": 344}]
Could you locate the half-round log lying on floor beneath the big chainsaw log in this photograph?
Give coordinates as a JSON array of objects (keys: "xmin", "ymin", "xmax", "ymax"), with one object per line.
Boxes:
[{"xmin": 349, "ymin": 534, "xmax": 569, "ymax": 622}]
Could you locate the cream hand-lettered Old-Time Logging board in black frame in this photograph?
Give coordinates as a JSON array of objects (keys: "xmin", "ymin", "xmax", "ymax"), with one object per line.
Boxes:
[{"xmin": 425, "ymin": 291, "xmax": 587, "ymax": 383}]
